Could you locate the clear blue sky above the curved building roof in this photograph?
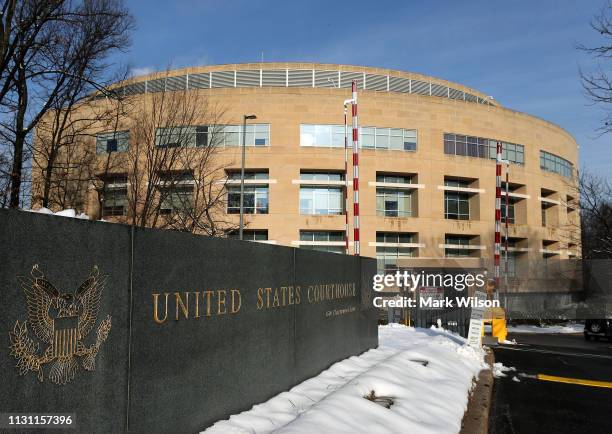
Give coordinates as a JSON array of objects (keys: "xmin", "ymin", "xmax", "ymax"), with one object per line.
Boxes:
[{"xmin": 117, "ymin": 0, "xmax": 612, "ymax": 175}]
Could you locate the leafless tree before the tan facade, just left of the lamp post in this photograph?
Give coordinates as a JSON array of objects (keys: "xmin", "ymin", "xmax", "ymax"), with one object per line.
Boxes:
[{"xmin": 124, "ymin": 79, "xmax": 237, "ymax": 235}]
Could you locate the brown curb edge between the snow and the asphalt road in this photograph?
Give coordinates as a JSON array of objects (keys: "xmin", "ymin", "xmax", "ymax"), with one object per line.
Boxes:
[{"xmin": 460, "ymin": 349, "xmax": 495, "ymax": 434}]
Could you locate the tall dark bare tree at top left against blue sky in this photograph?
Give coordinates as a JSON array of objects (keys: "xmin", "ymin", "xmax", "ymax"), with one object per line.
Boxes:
[{"xmin": 0, "ymin": 0, "xmax": 132, "ymax": 208}]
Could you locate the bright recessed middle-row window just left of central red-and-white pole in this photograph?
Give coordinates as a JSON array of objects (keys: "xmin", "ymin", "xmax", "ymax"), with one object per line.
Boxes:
[{"xmin": 300, "ymin": 172, "xmax": 344, "ymax": 215}]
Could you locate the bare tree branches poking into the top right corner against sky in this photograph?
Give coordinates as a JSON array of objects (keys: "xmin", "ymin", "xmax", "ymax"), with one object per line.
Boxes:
[{"xmin": 578, "ymin": 2, "xmax": 612, "ymax": 134}]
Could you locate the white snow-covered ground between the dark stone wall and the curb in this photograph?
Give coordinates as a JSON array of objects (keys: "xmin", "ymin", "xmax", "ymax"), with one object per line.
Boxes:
[{"xmin": 205, "ymin": 324, "xmax": 488, "ymax": 434}]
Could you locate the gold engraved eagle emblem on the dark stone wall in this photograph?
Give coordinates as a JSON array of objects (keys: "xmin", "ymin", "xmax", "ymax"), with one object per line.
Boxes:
[{"xmin": 9, "ymin": 265, "xmax": 111, "ymax": 384}]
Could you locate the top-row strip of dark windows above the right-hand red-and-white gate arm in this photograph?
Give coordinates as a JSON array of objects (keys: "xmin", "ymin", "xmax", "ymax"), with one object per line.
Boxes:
[{"xmin": 444, "ymin": 133, "xmax": 525, "ymax": 164}]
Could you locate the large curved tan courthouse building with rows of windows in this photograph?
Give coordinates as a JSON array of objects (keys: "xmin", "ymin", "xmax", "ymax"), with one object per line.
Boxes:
[{"xmin": 33, "ymin": 63, "xmax": 580, "ymax": 272}]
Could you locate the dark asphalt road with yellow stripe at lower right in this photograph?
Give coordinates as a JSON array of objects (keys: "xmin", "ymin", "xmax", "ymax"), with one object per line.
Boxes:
[{"xmin": 489, "ymin": 334, "xmax": 612, "ymax": 434}]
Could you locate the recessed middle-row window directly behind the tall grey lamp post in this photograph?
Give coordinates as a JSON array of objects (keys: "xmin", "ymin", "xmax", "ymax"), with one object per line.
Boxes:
[{"xmin": 227, "ymin": 171, "xmax": 269, "ymax": 214}]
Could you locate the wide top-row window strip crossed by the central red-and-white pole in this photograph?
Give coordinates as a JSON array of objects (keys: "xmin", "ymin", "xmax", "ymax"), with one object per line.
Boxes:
[{"xmin": 300, "ymin": 124, "xmax": 417, "ymax": 151}]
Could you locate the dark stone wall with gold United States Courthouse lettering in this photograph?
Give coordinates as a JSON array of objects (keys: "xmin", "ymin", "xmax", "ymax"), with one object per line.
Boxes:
[{"xmin": 0, "ymin": 210, "xmax": 378, "ymax": 433}]
